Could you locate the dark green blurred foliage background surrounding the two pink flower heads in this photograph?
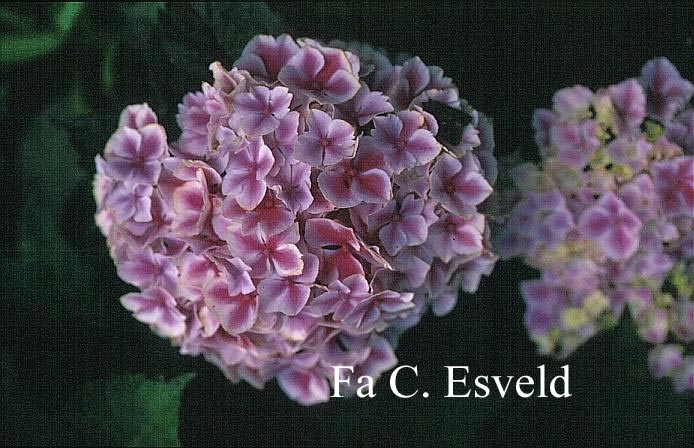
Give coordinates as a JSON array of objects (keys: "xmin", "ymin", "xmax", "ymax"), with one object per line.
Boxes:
[{"xmin": 0, "ymin": 2, "xmax": 694, "ymax": 446}]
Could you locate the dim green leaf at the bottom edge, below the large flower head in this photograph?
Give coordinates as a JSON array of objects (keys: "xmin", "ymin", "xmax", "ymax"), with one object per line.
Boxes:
[{"xmin": 66, "ymin": 374, "xmax": 195, "ymax": 446}]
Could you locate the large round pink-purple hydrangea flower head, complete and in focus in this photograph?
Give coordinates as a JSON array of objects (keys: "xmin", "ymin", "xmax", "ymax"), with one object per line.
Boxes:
[{"xmin": 94, "ymin": 35, "xmax": 496, "ymax": 405}]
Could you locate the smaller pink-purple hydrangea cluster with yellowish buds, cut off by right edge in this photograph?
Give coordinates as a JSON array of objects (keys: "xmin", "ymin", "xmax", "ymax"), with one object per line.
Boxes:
[{"xmin": 499, "ymin": 58, "xmax": 694, "ymax": 391}]
